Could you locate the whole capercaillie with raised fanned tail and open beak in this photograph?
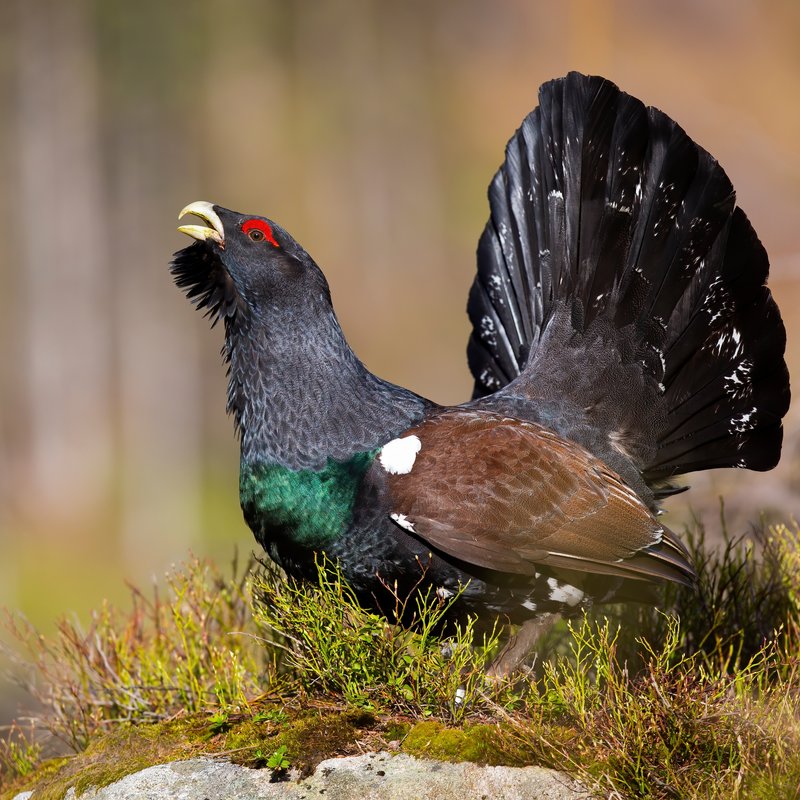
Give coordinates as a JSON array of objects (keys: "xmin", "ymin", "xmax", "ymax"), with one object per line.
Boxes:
[{"xmin": 171, "ymin": 72, "xmax": 790, "ymax": 664}]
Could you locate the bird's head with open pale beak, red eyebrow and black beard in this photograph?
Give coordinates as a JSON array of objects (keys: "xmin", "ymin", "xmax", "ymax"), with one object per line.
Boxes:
[{"xmin": 170, "ymin": 200, "xmax": 330, "ymax": 323}]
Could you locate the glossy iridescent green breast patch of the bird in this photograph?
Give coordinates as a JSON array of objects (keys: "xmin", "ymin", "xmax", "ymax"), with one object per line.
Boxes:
[{"xmin": 239, "ymin": 450, "xmax": 377, "ymax": 548}]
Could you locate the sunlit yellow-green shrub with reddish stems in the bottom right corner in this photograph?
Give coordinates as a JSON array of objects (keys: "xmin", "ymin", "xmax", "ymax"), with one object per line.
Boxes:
[{"xmin": 516, "ymin": 617, "xmax": 800, "ymax": 798}]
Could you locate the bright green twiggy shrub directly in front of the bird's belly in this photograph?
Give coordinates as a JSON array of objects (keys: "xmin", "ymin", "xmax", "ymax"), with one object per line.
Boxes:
[{"xmin": 253, "ymin": 563, "xmax": 499, "ymax": 721}]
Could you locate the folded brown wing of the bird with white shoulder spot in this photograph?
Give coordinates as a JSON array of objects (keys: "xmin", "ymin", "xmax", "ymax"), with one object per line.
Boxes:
[{"xmin": 372, "ymin": 410, "xmax": 693, "ymax": 582}]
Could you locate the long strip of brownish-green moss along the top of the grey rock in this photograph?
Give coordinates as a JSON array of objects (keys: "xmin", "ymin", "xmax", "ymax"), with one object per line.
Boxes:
[{"xmin": 10, "ymin": 704, "xmax": 552, "ymax": 800}]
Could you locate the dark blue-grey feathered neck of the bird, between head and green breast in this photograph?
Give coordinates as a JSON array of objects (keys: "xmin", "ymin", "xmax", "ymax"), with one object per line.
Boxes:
[{"xmin": 225, "ymin": 304, "xmax": 431, "ymax": 470}]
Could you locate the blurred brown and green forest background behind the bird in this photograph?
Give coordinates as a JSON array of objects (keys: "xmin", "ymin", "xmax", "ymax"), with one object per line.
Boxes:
[{"xmin": 0, "ymin": 0, "xmax": 800, "ymax": 718}]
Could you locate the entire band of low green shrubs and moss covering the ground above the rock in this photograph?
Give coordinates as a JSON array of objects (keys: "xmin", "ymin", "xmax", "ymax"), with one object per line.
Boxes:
[{"xmin": 0, "ymin": 526, "xmax": 800, "ymax": 800}]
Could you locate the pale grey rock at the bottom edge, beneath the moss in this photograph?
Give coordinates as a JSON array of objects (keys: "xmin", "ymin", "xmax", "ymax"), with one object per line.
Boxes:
[{"xmin": 15, "ymin": 753, "xmax": 592, "ymax": 800}]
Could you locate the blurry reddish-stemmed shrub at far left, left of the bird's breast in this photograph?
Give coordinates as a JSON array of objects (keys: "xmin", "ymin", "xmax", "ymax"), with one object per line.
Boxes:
[{"xmin": 0, "ymin": 561, "xmax": 270, "ymax": 752}]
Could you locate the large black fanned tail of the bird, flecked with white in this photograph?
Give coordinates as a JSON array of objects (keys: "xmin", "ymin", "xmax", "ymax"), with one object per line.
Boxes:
[{"xmin": 468, "ymin": 73, "xmax": 789, "ymax": 482}]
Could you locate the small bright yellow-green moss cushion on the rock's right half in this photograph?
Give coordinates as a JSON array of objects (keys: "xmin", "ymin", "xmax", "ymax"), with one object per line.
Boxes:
[{"xmin": 402, "ymin": 721, "xmax": 532, "ymax": 766}]
